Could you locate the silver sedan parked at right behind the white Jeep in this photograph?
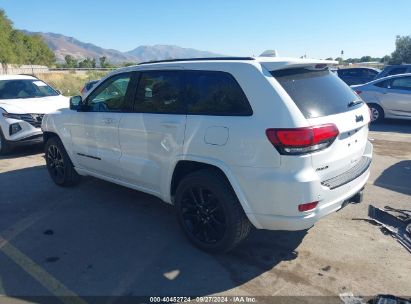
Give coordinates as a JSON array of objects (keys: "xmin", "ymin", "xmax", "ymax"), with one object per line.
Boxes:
[{"xmin": 351, "ymin": 73, "xmax": 411, "ymax": 122}]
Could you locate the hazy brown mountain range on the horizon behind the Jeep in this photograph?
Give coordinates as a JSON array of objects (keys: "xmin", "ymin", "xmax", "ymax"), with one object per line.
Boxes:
[{"xmin": 23, "ymin": 31, "xmax": 223, "ymax": 64}]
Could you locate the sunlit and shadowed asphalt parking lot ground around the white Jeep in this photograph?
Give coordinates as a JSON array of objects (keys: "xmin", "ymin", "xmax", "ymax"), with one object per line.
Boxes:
[{"xmin": 0, "ymin": 121, "xmax": 411, "ymax": 302}]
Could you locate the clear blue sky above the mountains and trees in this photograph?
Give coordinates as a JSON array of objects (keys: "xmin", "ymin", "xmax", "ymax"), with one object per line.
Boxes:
[{"xmin": 0, "ymin": 0, "xmax": 411, "ymax": 58}]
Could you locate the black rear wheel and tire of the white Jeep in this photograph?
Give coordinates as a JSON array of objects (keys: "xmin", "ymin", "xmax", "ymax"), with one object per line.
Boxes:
[{"xmin": 175, "ymin": 169, "xmax": 252, "ymax": 253}]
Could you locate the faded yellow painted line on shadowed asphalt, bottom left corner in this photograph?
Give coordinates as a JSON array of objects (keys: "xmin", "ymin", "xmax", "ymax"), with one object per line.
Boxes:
[{"xmin": 0, "ymin": 235, "xmax": 87, "ymax": 304}]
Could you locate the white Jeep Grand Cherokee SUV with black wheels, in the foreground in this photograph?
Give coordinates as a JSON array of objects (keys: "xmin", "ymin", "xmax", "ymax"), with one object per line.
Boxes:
[{"xmin": 42, "ymin": 57, "xmax": 372, "ymax": 252}]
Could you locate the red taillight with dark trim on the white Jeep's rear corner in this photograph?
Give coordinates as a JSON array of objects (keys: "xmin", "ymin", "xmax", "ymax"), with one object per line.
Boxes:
[{"xmin": 265, "ymin": 124, "xmax": 340, "ymax": 155}]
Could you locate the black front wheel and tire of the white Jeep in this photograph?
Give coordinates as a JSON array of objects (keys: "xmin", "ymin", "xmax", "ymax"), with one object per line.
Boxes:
[{"xmin": 44, "ymin": 137, "xmax": 80, "ymax": 187}]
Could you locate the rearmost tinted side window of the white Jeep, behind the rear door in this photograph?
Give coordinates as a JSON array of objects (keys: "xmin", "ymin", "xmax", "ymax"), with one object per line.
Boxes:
[{"xmin": 184, "ymin": 71, "xmax": 253, "ymax": 116}]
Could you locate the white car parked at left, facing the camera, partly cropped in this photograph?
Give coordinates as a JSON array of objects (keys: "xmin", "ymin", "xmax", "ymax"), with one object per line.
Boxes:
[{"xmin": 0, "ymin": 75, "xmax": 69, "ymax": 154}]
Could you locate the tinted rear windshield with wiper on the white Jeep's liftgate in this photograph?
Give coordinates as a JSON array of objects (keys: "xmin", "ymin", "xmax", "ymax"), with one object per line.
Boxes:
[{"xmin": 271, "ymin": 68, "xmax": 361, "ymax": 118}]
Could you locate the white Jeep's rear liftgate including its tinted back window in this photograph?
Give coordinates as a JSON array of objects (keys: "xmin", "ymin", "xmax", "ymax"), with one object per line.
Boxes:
[{"xmin": 271, "ymin": 65, "xmax": 370, "ymax": 183}]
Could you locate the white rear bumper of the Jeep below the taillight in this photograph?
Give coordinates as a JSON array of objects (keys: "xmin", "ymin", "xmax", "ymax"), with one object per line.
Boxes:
[{"xmin": 236, "ymin": 142, "xmax": 373, "ymax": 230}]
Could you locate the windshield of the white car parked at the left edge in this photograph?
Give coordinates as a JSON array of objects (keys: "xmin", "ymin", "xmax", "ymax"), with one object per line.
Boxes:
[{"xmin": 0, "ymin": 79, "xmax": 59, "ymax": 99}]
